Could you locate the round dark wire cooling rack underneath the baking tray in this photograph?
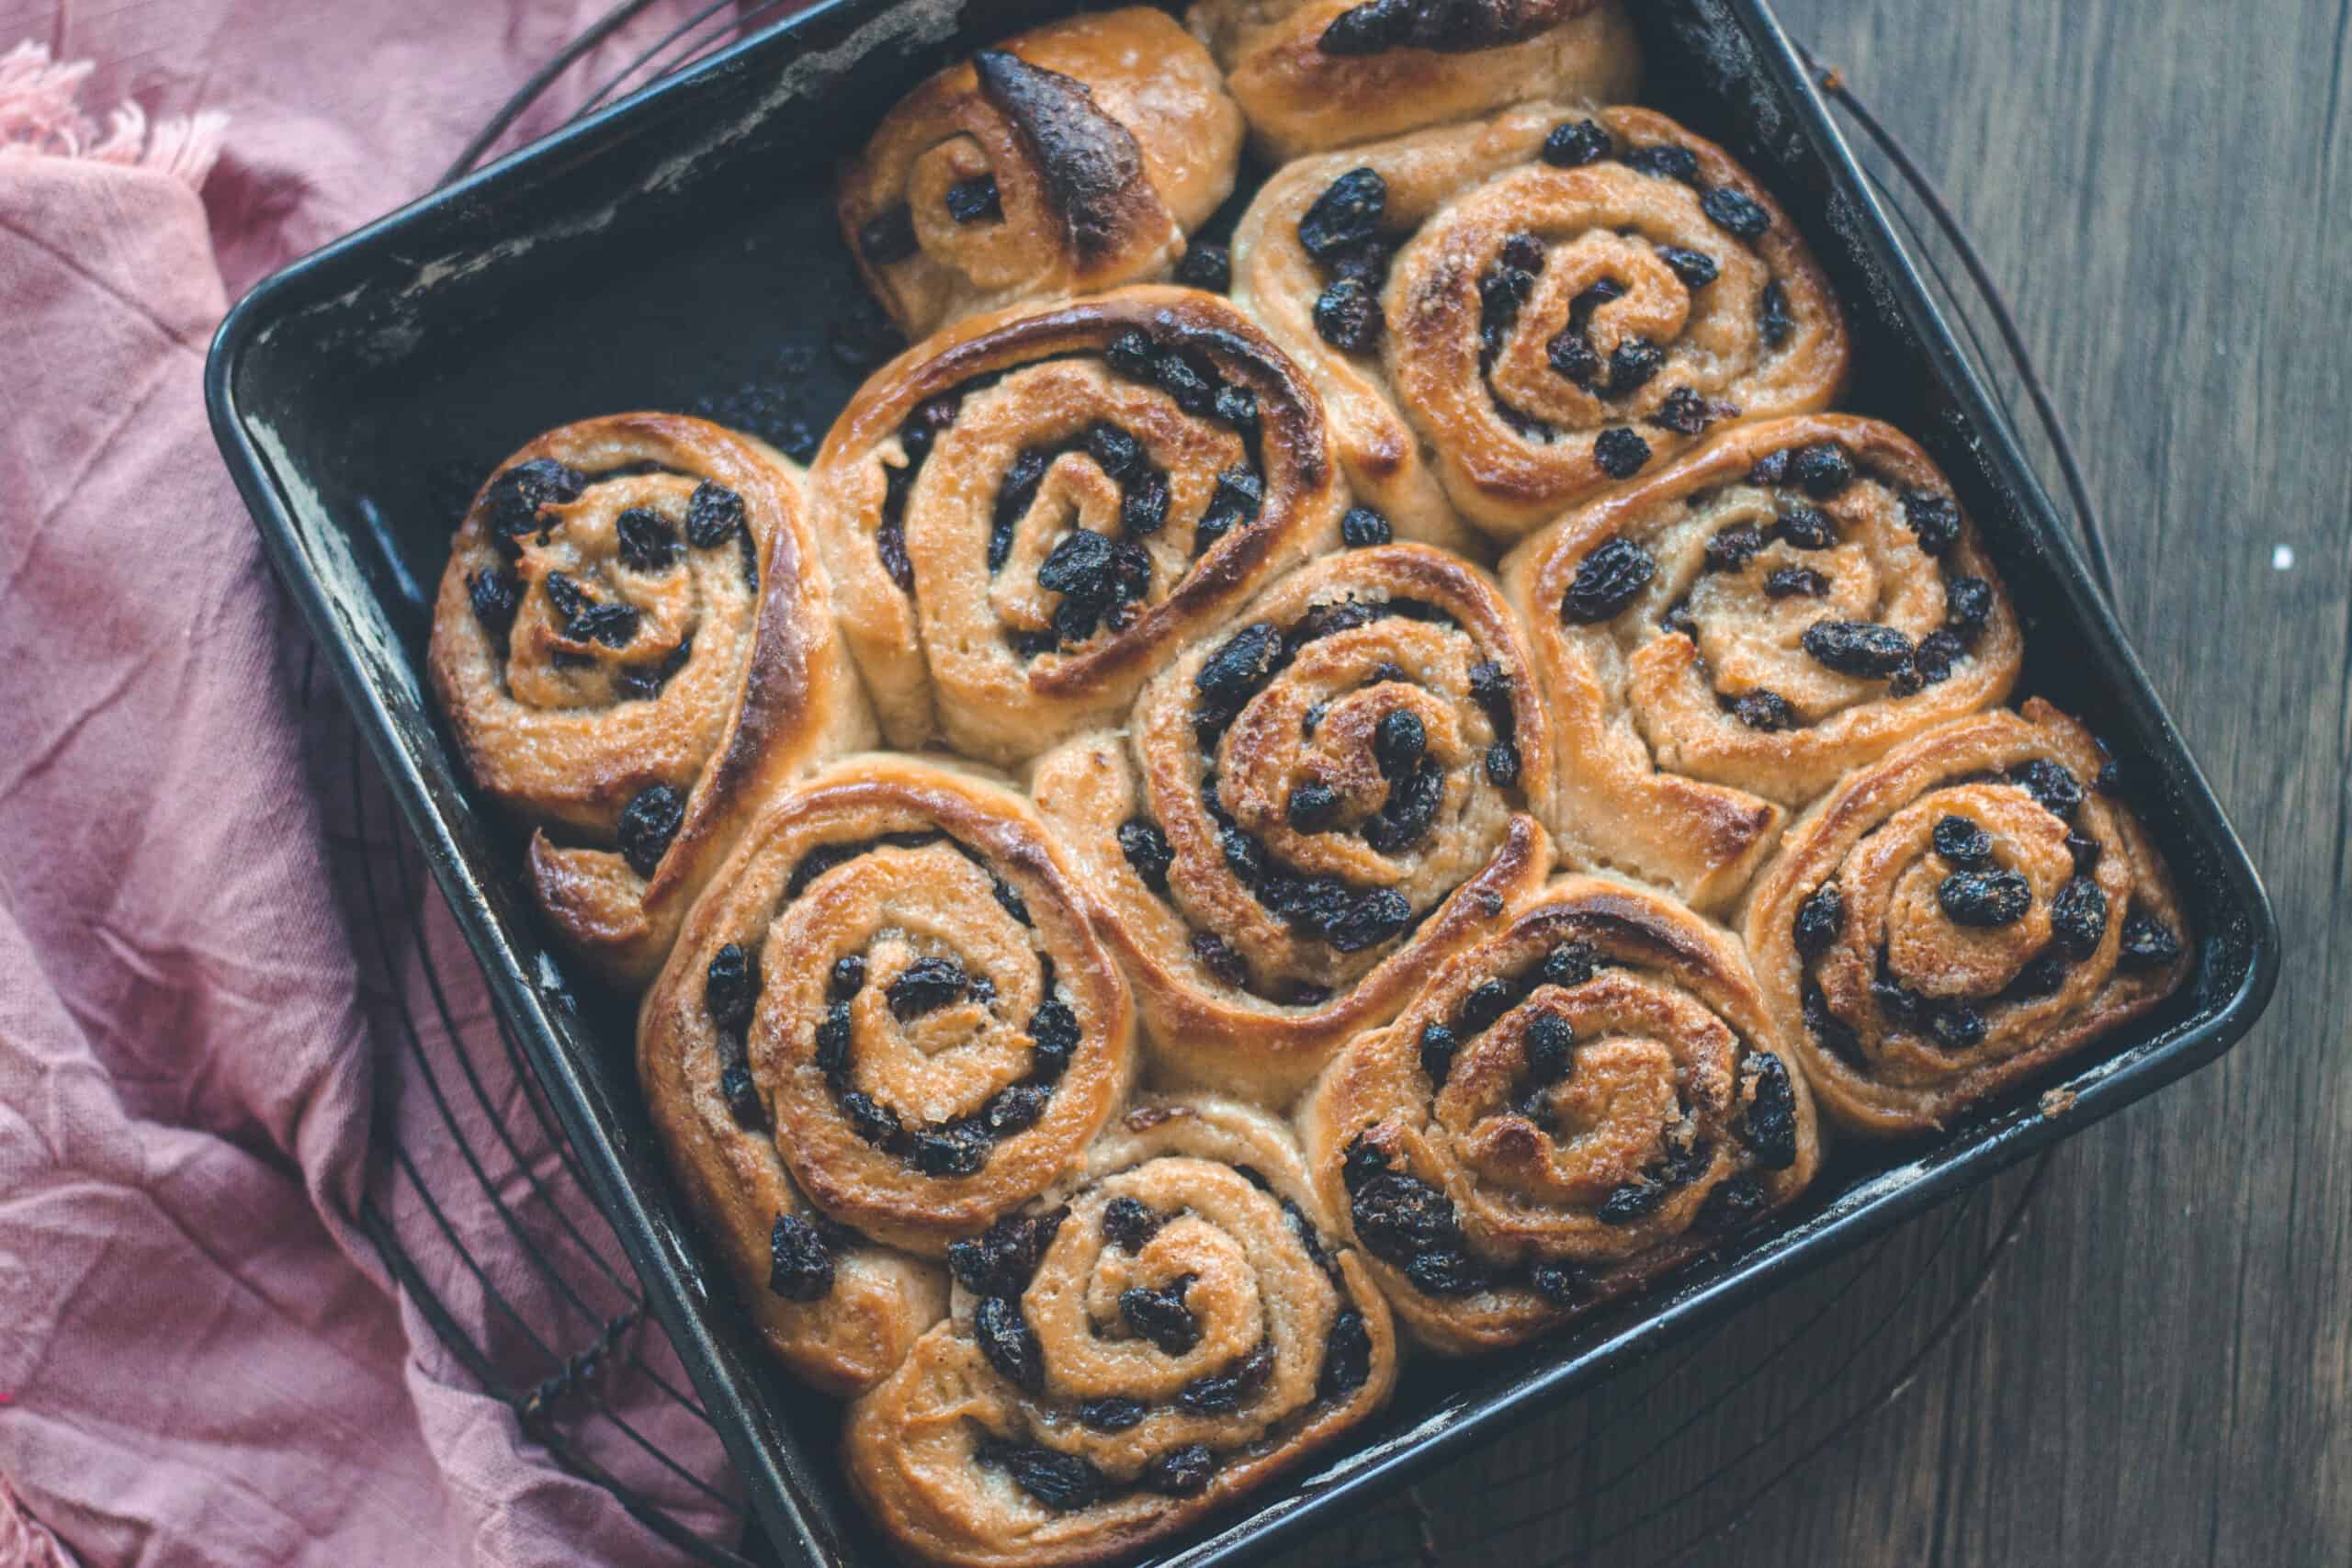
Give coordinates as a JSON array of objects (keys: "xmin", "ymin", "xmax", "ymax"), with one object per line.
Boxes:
[{"xmin": 301, "ymin": 0, "xmax": 2112, "ymax": 1568}]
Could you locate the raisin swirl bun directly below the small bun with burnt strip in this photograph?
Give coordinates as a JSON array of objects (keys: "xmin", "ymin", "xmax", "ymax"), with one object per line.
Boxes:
[{"xmin": 809, "ymin": 289, "xmax": 1343, "ymax": 764}]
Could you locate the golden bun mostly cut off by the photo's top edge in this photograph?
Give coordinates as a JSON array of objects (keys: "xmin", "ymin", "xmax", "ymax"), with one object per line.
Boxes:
[{"xmin": 1185, "ymin": 0, "xmax": 1642, "ymax": 160}]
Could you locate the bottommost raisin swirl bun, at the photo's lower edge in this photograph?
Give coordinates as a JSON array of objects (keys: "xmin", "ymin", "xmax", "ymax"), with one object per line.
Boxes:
[{"xmin": 844, "ymin": 1098, "xmax": 1397, "ymax": 1568}]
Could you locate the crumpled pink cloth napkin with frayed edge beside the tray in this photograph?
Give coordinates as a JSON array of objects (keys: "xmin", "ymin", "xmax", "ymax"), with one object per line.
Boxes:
[{"xmin": 0, "ymin": 0, "xmax": 799, "ymax": 1568}]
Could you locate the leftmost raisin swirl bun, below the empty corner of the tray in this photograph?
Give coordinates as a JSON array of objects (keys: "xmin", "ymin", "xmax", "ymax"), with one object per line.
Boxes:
[{"xmin": 425, "ymin": 413, "xmax": 875, "ymax": 985}]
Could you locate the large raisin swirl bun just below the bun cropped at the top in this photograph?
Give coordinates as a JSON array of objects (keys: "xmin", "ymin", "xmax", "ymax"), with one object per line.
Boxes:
[{"xmin": 1232, "ymin": 106, "xmax": 1847, "ymax": 538}]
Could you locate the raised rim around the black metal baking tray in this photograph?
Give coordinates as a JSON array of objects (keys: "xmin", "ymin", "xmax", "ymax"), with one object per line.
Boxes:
[{"xmin": 205, "ymin": 0, "xmax": 2279, "ymax": 1568}]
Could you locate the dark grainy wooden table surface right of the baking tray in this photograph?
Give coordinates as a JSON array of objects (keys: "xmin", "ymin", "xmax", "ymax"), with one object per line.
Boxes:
[{"xmin": 1284, "ymin": 0, "xmax": 2352, "ymax": 1568}]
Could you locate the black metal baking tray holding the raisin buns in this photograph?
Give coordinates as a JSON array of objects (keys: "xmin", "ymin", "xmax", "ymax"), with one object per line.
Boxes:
[{"xmin": 207, "ymin": 0, "xmax": 2279, "ymax": 1568}]
